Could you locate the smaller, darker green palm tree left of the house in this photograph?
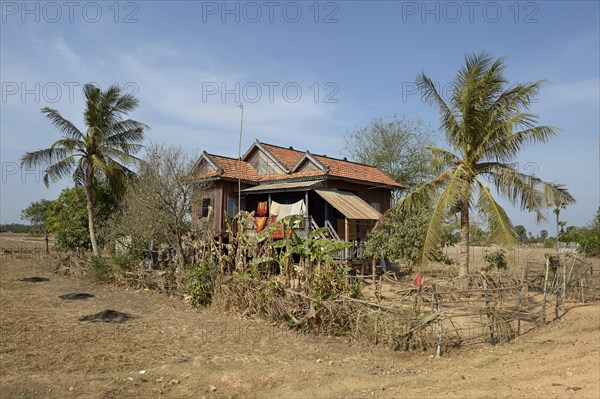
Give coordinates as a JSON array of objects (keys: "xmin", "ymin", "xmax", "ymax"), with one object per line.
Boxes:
[{"xmin": 21, "ymin": 84, "xmax": 148, "ymax": 256}]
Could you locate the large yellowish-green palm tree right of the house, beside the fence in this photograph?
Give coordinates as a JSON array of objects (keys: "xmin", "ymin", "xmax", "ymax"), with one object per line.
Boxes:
[{"xmin": 398, "ymin": 54, "xmax": 575, "ymax": 276}]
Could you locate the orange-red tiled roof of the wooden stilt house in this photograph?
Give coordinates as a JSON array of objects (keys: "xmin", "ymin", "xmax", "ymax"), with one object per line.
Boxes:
[{"xmin": 193, "ymin": 142, "xmax": 403, "ymax": 188}]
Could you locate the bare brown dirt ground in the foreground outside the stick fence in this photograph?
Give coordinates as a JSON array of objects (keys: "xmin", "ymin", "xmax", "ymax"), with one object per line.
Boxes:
[{"xmin": 0, "ymin": 257, "xmax": 600, "ymax": 398}]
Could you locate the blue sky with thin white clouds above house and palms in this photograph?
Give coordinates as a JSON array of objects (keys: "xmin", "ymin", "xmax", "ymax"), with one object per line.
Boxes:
[{"xmin": 0, "ymin": 1, "xmax": 600, "ymax": 233}]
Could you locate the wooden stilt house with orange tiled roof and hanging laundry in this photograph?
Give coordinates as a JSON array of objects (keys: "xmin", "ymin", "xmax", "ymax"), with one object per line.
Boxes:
[{"xmin": 191, "ymin": 140, "xmax": 403, "ymax": 260}]
